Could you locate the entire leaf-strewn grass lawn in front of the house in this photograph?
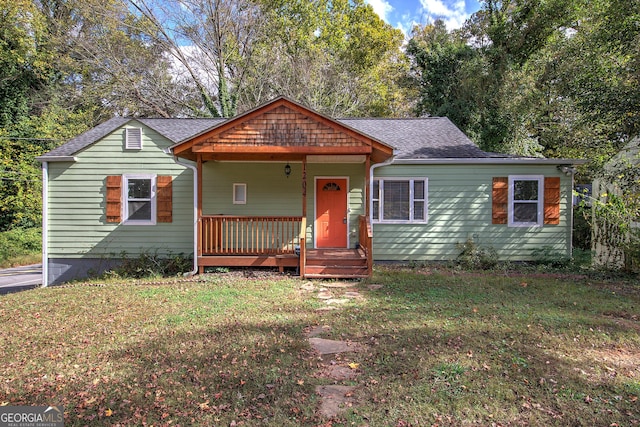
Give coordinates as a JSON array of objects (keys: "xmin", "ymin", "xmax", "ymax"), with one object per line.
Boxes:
[{"xmin": 0, "ymin": 267, "xmax": 640, "ymax": 426}]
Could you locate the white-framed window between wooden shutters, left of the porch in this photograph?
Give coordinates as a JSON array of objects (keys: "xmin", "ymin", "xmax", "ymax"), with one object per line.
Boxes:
[{"xmin": 123, "ymin": 175, "xmax": 156, "ymax": 225}]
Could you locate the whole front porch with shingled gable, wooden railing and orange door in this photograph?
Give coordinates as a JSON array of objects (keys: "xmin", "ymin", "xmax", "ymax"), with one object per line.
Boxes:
[{"xmin": 172, "ymin": 98, "xmax": 393, "ymax": 278}]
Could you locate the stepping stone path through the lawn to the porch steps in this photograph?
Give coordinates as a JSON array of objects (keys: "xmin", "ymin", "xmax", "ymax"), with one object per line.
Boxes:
[{"xmin": 301, "ymin": 282, "xmax": 379, "ymax": 419}]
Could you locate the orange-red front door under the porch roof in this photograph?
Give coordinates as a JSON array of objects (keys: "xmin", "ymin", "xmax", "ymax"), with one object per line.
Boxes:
[{"xmin": 316, "ymin": 178, "xmax": 347, "ymax": 248}]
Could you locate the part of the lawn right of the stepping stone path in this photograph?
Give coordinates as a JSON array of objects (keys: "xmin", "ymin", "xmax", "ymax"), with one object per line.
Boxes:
[{"xmin": 345, "ymin": 275, "xmax": 640, "ymax": 426}]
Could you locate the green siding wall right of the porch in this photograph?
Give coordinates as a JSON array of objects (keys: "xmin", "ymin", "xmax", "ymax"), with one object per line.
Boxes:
[{"xmin": 373, "ymin": 165, "xmax": 573, "ymax": 262}]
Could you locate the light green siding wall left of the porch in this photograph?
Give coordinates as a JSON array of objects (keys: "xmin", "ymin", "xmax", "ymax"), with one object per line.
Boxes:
[{"xmin": 47, "ymin": 122, "xmax": 193, "ymax": 283}]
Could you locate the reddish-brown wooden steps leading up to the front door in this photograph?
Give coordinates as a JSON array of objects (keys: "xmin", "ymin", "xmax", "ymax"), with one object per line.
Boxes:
[{"xmin": 304, "ymin": 249, "xmax": 369, "ymax": 279}]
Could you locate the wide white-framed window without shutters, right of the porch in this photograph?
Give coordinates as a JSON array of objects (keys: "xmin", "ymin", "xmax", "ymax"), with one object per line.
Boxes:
[{"xmin": 371, "ymin": 178, "xmax": 428, "ymax": 223}]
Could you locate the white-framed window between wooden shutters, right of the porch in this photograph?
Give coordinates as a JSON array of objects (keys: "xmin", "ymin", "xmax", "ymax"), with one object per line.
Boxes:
[{"xmin": 509, "ymin": 175, "xmax": 544, "ymax": 227}]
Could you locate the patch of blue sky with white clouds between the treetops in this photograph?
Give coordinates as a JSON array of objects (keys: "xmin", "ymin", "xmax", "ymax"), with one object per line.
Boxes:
[{"xmin": 365, "ymin": 0, "xmax": 481, "ymax": 35}]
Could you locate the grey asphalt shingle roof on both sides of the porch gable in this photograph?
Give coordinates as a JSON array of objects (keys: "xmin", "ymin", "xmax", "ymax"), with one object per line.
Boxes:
[{"xmin": 40, "ymin": 117, "xmax": 497, "ymax": 161}]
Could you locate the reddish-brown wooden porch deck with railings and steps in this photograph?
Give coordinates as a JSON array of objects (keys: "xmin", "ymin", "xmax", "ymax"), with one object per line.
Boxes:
[{"xmin": 198, "ymin": 215, "xmax": 373, "ymax": 278}]
